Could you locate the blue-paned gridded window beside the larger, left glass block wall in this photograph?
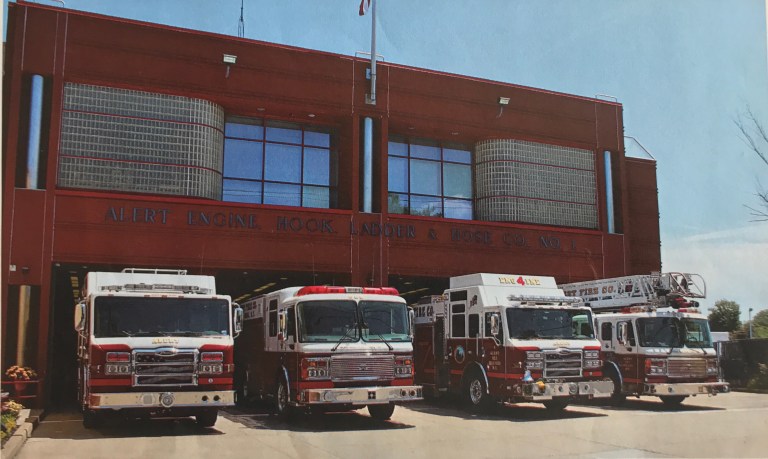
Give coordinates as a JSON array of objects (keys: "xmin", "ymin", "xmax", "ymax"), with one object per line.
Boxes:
[{"xmin": 223, "ymin": 117, "xmax": 338, "ymax": 209}]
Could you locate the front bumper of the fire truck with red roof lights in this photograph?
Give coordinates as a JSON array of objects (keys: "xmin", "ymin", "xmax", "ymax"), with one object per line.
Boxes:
[{"xmin": 299, "ymin": 386, "xmax": 422, "ymax": 405}]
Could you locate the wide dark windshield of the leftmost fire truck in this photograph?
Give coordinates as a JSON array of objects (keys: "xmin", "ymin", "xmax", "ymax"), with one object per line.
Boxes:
[{"xmin": 93, "ymin": 296, "xmax": 230, "ymax": 338}]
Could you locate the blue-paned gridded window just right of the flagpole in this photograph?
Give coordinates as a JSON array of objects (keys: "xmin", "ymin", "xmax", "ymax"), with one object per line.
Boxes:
[{"xmin": 387, "ymin": 137, "xmax": 472, "ymax": 220}]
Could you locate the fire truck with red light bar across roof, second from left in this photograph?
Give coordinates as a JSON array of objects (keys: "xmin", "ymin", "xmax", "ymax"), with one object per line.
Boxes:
[{"xmin": 236, "ymin": 286, "xmax": 421, "ymax": 420}]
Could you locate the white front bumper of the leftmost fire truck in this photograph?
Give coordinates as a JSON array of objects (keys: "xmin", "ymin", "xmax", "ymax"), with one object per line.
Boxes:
[{"xmin": 89, "ymin": 390, "xmax": 235, "ymax": 410}]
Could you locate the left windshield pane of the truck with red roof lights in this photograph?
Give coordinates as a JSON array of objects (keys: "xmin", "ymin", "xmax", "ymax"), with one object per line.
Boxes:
[{"xmin": 296, "ymin": 300, "xmax": 360, "ymax": 343}]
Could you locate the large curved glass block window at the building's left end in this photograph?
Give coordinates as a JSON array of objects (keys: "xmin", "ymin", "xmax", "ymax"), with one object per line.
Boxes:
[{"xmin": 57, "ymin": 83, "xmax": 224, "ymax": 199}]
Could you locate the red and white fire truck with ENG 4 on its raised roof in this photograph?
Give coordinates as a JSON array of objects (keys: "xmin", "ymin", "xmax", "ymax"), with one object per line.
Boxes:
[{"xmin": 414, "ymin": 273, "xmax": 613, "ymax": 411}]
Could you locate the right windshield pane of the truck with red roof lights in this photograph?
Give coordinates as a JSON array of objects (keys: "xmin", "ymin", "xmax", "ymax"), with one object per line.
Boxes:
[{"xmin": 360, "ymin": 301, "xmax": 409, "ymax": 341}]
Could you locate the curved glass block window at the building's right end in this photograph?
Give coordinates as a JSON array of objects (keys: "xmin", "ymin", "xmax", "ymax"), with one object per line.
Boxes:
[{"xmin": 475, "ymin": 139, "xmax": 598, "ymax": 229}]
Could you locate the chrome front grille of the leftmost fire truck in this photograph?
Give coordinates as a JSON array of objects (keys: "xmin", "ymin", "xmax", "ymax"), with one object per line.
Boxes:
[{"xmin": 133, "ymin": 349, "xmax": 197, "ymax": 386}]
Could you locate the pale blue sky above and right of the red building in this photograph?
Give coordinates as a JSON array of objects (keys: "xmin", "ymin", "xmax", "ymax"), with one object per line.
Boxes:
[{"xmin": 4, "ymin": 0, "xmax": 768, "ymax": 321}]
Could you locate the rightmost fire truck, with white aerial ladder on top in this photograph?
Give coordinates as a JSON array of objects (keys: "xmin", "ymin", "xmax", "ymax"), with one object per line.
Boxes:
[{"xmin": 560, "ymin": 272, "xmax": 729, "ymax": 407}]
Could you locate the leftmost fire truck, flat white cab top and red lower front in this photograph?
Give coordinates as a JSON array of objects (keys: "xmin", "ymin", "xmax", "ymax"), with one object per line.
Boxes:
[{"xmin": 75, "ymin": 268, "xmax": 243, "ymax": 428}]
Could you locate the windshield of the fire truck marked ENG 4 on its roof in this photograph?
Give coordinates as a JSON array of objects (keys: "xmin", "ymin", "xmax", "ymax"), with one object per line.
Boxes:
[{"xmin": 507, "ymin": 307, "xmax": 595, "ymax": 339}]
